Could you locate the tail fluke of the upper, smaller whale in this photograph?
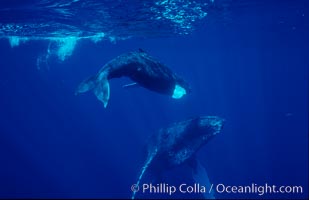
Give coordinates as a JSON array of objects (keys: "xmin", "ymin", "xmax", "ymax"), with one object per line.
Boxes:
[{"xmin": 75, "ymin": 73, "xmax": 110, "ymax": 108}]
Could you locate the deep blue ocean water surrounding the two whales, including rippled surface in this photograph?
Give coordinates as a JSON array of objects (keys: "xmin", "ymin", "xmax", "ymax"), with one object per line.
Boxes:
[{"xmin": 0, "ymin": 0, "xmax": 309, "ymax": 199}]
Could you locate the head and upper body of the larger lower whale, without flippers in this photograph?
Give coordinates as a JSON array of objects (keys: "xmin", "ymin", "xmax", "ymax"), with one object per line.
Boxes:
[{"xmin": 149, "ymin": 116, "xmax": 224, "ymax": 168}]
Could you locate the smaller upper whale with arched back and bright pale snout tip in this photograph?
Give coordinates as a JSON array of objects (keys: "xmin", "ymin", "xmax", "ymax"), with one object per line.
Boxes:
[{"xmin": 75, "ymin": 49, "xmax": 190, "ymax": 108}]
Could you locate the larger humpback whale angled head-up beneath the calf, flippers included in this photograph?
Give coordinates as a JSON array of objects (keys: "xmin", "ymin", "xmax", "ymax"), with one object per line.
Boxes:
[{"xmin": 132, "ymin": 116, "xmax": 224, "ymax": 199}]
